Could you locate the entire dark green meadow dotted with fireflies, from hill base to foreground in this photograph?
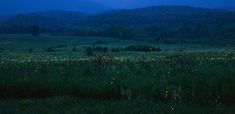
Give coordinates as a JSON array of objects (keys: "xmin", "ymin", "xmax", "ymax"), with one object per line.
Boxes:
[{"xmin": 0, "ymin": 34, "xmax": 235, "ymax": 114}]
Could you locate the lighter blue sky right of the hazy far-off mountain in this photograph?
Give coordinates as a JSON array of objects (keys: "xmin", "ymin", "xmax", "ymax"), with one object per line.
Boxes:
[{"xmin": 96, "ymin": 0, "xmax": 235, "ymax": 8}]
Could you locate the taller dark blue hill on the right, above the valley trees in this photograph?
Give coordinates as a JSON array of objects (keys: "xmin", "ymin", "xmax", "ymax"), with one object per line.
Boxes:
[{"xmin": 86, "ymin": 6, "xmax": 235, "ymax": 26}]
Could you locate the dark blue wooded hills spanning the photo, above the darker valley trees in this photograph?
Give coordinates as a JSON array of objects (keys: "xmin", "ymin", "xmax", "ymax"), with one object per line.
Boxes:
[{"xmin": 0, "ymin": 6, "xmax": 235, "ymax": 33}]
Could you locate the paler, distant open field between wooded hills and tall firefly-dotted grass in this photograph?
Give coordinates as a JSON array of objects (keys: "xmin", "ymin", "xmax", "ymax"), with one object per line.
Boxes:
[{"xmin": 0, "ymin": 34, "xmax": 235, "ymax": 56}]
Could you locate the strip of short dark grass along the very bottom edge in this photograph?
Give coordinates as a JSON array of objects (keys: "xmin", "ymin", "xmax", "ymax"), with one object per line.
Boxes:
[{"xmin": 0, "ymin": 97, "xmax": 235, "ymax": 114}]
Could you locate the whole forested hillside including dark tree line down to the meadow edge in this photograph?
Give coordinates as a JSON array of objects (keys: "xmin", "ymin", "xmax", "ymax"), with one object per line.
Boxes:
[{"xmin": 0, "ymin": 6, "xmax": 235, "ymax": 41}]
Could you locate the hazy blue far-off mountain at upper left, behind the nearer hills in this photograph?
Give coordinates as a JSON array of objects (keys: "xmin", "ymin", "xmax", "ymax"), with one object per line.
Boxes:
[{"xmin": 0, "ymin": 0, "xmax": 109, "ymax": 15}]
